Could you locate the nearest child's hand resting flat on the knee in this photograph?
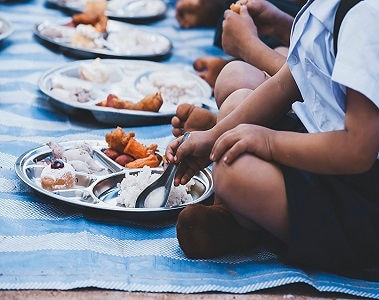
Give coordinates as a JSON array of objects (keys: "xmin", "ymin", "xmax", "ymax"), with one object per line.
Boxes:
[{"xmin": 211, "ymin": 124, "xmax": 275, "ymax": 164}]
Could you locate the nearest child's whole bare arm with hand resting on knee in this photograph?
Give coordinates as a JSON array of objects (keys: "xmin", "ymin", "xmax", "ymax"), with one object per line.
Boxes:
[{"xmin": 211, "ymin": 89, "xmax": 379, "ymax": 174}]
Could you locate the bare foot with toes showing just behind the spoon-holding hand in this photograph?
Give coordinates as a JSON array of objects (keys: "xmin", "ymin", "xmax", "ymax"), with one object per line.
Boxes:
[{"xmin": 171, "ymin": 103, "xmax": 216, "ymax": 137}]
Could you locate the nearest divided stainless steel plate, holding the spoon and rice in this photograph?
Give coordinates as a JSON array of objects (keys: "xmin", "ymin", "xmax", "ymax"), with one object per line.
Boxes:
[{"xmin": 15, "ymin": 140, "xmax": 213, "ymax": 221}]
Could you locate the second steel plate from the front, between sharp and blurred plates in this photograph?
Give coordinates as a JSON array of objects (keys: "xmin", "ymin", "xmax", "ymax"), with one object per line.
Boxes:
[{"xmin": 38, "ymin": 59, "xmax": 214, "ymax": 126}]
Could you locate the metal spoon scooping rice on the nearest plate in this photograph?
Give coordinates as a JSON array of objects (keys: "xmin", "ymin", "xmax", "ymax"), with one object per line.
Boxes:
[{"xmin": 135, "ymin": 132, "xmax": 190, "ymax": 208}]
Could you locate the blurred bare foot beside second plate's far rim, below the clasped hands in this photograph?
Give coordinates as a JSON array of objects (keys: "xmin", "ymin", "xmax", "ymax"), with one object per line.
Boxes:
[{"xmin": 193, "ymin": 57, "xmax": 229, "ymax": 89}]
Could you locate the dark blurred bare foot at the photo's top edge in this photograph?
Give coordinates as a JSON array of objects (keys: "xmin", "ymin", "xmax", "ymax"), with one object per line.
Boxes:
[{"xmin": 175, "ymin": 0, "xmax": 224, "ymax": 28}]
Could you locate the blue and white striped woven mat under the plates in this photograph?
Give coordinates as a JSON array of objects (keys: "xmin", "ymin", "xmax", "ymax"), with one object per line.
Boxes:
[{"xmin": 0, "ymin": 0, "xmax": 379, "ymax": 299}]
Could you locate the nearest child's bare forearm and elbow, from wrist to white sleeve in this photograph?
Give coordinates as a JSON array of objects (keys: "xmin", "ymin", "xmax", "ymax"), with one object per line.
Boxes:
[{"xmin": 270, "ymin": 89, "xmax": 379, "ymax": 174}]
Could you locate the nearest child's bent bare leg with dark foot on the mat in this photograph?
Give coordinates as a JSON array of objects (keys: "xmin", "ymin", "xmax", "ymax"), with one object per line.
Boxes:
[{"xmin": 176, "ymin": 150, "xmax": 288, "ymax": 258}]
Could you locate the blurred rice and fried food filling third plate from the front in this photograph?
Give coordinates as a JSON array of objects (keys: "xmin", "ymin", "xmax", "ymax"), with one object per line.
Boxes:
[{"xmin": 36, "ymin": 14, "xmax": 172, "ymax": 58}]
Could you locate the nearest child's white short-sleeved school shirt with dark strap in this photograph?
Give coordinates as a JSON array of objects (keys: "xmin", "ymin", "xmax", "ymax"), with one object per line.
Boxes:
[{"xmin": 287, "ymin": 0, "xmax": 379, "ymax": 158}]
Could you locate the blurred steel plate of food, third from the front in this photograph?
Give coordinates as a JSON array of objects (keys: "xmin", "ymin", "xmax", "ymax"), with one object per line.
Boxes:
[{"xmin": 34, "ymin": 18, "xmax": 172, "ymax": 60}]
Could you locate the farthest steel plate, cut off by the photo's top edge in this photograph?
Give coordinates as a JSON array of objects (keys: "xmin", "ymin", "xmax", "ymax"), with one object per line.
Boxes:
[{"xmin": 47, "ymin": 0, "xmax": 168, "ymax": 23}]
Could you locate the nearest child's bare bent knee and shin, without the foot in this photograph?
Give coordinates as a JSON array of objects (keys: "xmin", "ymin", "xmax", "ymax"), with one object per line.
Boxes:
[{"xmin": 212, "ymin": 154, "xmax": 289, "ymax": 242}]
